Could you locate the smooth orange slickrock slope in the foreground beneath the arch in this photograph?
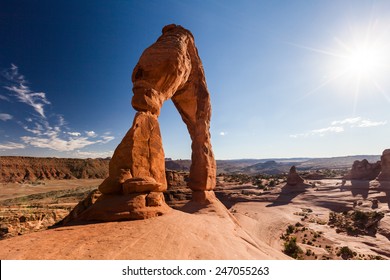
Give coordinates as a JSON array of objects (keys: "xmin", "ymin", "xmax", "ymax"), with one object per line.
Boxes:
[{"xmin": 0, "ymin": 196, "xmax": 288, "ymax": 260}]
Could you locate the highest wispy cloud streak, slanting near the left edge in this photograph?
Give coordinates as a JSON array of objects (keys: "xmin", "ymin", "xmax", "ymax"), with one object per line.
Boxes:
[{"xmin": 3, "ymin": 64, "xmax": 50, "ymax": 118}]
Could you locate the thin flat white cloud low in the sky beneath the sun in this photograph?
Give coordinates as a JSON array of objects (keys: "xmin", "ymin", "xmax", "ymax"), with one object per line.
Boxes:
[{"xmin": 290, "ymin": 117, "xmax": 387, "ymax": 138}]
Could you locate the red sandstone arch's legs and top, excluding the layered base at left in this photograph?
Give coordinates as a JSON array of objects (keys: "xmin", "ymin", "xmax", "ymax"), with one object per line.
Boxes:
[{"xmin": 99, "ymin": 24, "xmax": 216, "ymax": 194}]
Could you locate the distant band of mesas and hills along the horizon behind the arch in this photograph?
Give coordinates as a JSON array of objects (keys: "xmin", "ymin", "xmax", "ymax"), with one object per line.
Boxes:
[{"xmin": 0, "ymin": 155, "xmax": 380, "ymax": 182}]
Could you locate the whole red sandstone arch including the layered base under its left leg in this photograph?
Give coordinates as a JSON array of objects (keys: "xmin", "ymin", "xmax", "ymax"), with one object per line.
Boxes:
[{"xmin": 62, "ymin": 24, "xmax": 216, "ymax": 224}]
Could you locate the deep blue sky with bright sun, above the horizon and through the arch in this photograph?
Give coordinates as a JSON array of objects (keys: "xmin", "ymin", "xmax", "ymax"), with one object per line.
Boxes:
[{"xmin": 0, "ymin": 0, "xmax": 390, "ymax": 159}]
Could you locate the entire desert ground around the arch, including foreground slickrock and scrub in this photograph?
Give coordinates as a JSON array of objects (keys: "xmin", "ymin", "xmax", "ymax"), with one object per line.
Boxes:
[{"xmin": 0, "ymin": 175, "xmax": 390, "ymax": 260}]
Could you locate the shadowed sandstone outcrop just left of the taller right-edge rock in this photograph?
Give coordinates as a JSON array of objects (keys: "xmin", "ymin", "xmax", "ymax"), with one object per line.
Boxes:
[{"xmin": 344, "ymin": 159, "xmax": 381, "ymax": 181}]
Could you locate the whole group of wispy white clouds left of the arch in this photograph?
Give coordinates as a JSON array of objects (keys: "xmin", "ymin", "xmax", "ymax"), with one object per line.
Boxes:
[{"xmin": 0, "ymin": 64, "xmax": 115, "ymax": 155}]
